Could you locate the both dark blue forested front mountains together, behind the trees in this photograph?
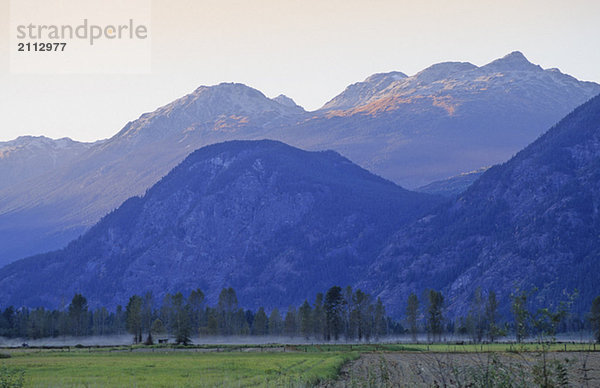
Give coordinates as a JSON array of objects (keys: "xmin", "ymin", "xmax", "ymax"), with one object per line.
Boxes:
[{"xmin": 0, "ymin": 95, "xmax": 600, "ymax": 317}]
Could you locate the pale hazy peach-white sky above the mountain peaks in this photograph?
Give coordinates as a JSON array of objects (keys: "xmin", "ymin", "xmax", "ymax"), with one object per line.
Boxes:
[{"xmin": 0, "ymin": 0, "xmax": 600, "ymax": 141}]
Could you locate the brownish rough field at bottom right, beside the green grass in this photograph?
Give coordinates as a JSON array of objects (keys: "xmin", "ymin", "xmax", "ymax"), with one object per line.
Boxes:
[{"xmin": 325, "ymin": 352, "xmax": 600, "ymax": 388}]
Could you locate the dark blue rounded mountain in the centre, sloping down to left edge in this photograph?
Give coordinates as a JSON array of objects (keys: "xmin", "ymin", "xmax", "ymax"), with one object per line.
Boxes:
[{"xmin": 0, "ymin": 141, "xmax": 440, "ymax": 307}]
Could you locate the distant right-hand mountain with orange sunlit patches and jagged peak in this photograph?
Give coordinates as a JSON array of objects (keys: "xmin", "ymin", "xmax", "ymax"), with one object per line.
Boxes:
[{"xmin": 294, "ymin": 52, "xmax": 600, "ymax": 188}]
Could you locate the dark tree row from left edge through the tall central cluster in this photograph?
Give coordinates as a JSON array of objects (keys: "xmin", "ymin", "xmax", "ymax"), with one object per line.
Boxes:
[{"xmin": 0, "ymin": 286, "xmax": 394, "ymax": 344}]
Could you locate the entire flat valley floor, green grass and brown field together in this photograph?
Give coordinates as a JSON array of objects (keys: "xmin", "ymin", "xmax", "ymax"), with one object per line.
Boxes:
[{"xmin": 0, "ymin": 344, "xmax": 600, "ymax": 388}]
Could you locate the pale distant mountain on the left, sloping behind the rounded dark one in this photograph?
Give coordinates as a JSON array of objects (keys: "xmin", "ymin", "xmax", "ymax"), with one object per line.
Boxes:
[{"xmin": 0, "ymin": 84, "xmax": 302, "ymax": 265}]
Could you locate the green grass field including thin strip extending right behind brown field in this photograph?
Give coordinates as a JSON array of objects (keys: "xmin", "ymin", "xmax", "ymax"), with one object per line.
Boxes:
[{"xmin": 0, "ymin": 344, "xmax": 600, "ymax": 387}]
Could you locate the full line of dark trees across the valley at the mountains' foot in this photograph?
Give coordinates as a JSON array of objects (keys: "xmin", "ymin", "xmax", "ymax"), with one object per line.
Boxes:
[{"xmin": 0, "ymin": 286, "xmax": 600, "ymax": 344}]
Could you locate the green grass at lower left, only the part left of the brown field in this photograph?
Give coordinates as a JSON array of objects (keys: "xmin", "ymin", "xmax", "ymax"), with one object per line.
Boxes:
[{"xmin": 1, "ymin": 350, "xmax": 358, "ymax": 387}]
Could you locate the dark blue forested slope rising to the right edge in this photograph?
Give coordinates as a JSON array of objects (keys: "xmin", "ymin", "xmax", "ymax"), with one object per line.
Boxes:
[{"xmin": 361, "ymin": 96, "xmax": 600, "ymax": 315}]
